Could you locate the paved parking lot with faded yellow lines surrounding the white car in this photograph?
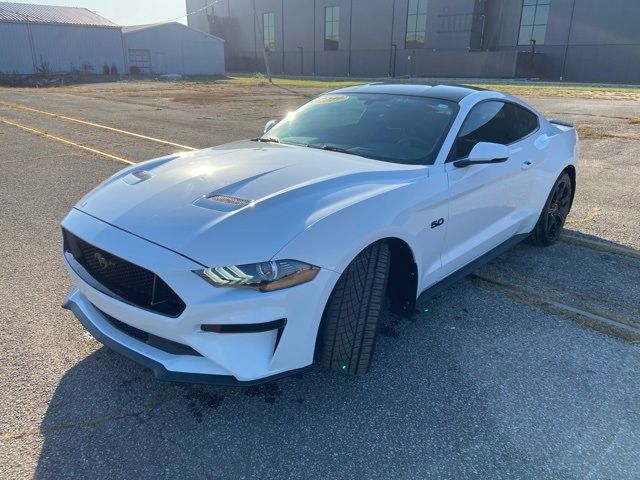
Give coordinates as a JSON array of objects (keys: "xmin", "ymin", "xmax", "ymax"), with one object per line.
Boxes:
[{"xmin": 0, "ymin": 82, "xmax": 640, "ymax": 479}]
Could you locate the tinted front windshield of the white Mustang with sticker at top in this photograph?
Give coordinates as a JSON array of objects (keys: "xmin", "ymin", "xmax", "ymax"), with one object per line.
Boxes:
[{"xmin": 262, "ymin": 93, "xmax": 458, "ymax": 165}]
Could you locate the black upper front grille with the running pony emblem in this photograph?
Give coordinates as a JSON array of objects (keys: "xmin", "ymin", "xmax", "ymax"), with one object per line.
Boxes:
[{"xmin": 62, "ymin": 229, "xmax": 186, "ymax": 317}]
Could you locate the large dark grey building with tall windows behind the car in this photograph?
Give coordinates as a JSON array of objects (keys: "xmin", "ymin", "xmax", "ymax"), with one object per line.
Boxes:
[{"xmin": 187, "ymin": 0, "xmax": 640, "ymax": 83}]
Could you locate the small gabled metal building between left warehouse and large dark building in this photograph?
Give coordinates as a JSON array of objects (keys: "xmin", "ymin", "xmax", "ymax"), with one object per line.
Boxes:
[{"xmin": 122, "ymin": 23, "xmax": 224, "ymax": 75}]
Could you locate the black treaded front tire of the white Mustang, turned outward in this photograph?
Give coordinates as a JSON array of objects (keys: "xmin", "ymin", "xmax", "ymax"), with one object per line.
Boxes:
[{"xmin": 318, "ymin": 242, "xmax": 391, "ymax": 375}]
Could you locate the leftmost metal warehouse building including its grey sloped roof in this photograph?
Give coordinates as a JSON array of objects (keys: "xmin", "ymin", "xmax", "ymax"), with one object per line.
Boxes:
[{"xmin": 0, "ymin": 2, "xmax": 125, "ymax": 74}]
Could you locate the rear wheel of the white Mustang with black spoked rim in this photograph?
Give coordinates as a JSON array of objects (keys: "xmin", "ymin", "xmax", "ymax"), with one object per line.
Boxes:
[{"xmin": 531, "ymin": 172, "xmax": 573, "ymax": 247}]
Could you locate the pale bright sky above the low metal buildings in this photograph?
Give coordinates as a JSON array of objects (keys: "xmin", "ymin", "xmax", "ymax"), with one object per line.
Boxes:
[{"xmin": 8, "ymin": 0, "xmax": 187, "ymax": 25}]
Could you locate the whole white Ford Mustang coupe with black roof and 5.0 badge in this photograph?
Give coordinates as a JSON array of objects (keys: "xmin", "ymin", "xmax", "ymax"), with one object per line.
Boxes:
[{"xmin": 62, "ymin": 84, "xmax": 577, "ymax": 384}]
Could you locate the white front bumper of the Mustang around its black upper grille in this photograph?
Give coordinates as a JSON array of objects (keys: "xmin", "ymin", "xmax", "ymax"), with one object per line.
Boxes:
[{"xmin": 62, "ymin": 210, "xmax": 339, "ymax": 385}]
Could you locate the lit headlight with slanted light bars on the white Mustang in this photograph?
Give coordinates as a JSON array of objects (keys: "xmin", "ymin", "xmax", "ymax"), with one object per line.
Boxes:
[{"xmin": 195, "ymin": 260, "xmax": 320, "ymax": 292}]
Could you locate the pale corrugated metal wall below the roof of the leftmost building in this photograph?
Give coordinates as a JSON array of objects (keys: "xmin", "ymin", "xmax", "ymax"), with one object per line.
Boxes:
[{"xmin": 0, "ymin": 23, "xmax": 125, "ymax": 74}]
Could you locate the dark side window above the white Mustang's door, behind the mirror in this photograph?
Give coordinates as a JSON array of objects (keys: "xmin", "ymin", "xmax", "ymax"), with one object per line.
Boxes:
[{"xmin": 449, "ymin": 102, "xmax": 538, "ymax": 161}]
